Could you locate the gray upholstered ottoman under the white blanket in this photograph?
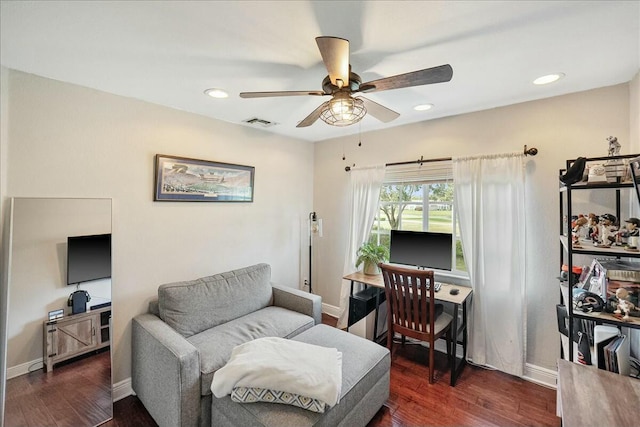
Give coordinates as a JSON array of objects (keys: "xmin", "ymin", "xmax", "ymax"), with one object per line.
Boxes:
[{"xmin": 211, "ymin": 325, "xmax": 391, "ymax": 427}]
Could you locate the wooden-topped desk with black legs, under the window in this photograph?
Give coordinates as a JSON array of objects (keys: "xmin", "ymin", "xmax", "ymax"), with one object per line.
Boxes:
[{"xmin": 343, "ymin": 271, "xmax": 473, "ymax": 386}]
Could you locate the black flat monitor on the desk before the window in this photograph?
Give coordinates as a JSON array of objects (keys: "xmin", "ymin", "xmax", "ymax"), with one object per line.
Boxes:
[{"xmin": 389, "ymin": 230, "xmax": 452, "ymax": 271}]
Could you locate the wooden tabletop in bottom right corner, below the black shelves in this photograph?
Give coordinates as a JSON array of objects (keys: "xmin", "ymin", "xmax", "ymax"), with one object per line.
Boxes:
[{"xmin": 558, "ymin": 359, "xmax": 640, "ymax": 427}]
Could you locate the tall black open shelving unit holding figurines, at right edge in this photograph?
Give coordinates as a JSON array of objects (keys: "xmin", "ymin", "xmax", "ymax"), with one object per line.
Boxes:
[{"xmin": 558, "ymin": 154, "xmax": 640, "ymax": 372}]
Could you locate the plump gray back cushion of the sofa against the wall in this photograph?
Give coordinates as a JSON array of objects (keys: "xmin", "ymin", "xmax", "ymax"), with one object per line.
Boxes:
[{"xmin": 158, "ymin": 264, "xmax": 272, "ymax": 337}]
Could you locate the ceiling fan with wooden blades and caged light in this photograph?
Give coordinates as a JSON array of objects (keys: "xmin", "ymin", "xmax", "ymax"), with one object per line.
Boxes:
[{"xmin": 240, "ymin": 36, "xmax": 453, "ymax": 127}]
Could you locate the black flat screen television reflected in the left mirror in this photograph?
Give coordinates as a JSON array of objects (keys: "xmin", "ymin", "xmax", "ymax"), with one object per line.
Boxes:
[{"xmin": 67, "ymin": 234, "xmax": 111, "ymax": 285}]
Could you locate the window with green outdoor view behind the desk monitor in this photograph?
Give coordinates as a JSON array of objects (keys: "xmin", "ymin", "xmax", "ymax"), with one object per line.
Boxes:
[{"xmin": 369, "ymin": 161, "xmax": 467, "ymax": 276}]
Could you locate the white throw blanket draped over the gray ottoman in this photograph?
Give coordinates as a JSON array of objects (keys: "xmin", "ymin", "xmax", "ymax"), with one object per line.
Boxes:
[{"xmin": 211, "ymin": 337, "xmax": 342, "ymax": 406}]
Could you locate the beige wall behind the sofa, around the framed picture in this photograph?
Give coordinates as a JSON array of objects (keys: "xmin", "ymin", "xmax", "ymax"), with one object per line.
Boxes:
[{"xmin": 2, "ymin": 71, "xmax": 313, "ymax": 383}]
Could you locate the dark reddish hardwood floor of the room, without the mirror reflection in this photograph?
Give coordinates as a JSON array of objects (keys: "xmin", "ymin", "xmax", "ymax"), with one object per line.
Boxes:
[{"xmin": 105, "ymin": 314, "xmax": 560, "ymax": 427}]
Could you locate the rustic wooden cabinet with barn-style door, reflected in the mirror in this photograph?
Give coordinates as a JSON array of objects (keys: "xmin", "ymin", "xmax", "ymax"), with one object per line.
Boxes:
[{"xmin": 44, "ymin": 307, "xmax": 111, "ymax": 371}]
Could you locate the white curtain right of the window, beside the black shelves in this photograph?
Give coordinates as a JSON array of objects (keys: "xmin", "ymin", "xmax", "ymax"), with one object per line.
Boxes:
[{"xmin": 453, "ymin": 153, "xmax": 526, "ymax": 376}]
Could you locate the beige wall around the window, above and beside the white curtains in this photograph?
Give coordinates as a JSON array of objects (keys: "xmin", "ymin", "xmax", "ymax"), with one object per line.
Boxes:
[{"xmin": 314, "ymin": 84, "xmax": 630, "ymax": 371}]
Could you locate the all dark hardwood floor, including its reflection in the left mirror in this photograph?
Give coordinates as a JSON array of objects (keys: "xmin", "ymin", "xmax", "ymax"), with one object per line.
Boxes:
[{"xmin": 5, "ymin": 315, "xmax": 560, "ymax": 427}]
